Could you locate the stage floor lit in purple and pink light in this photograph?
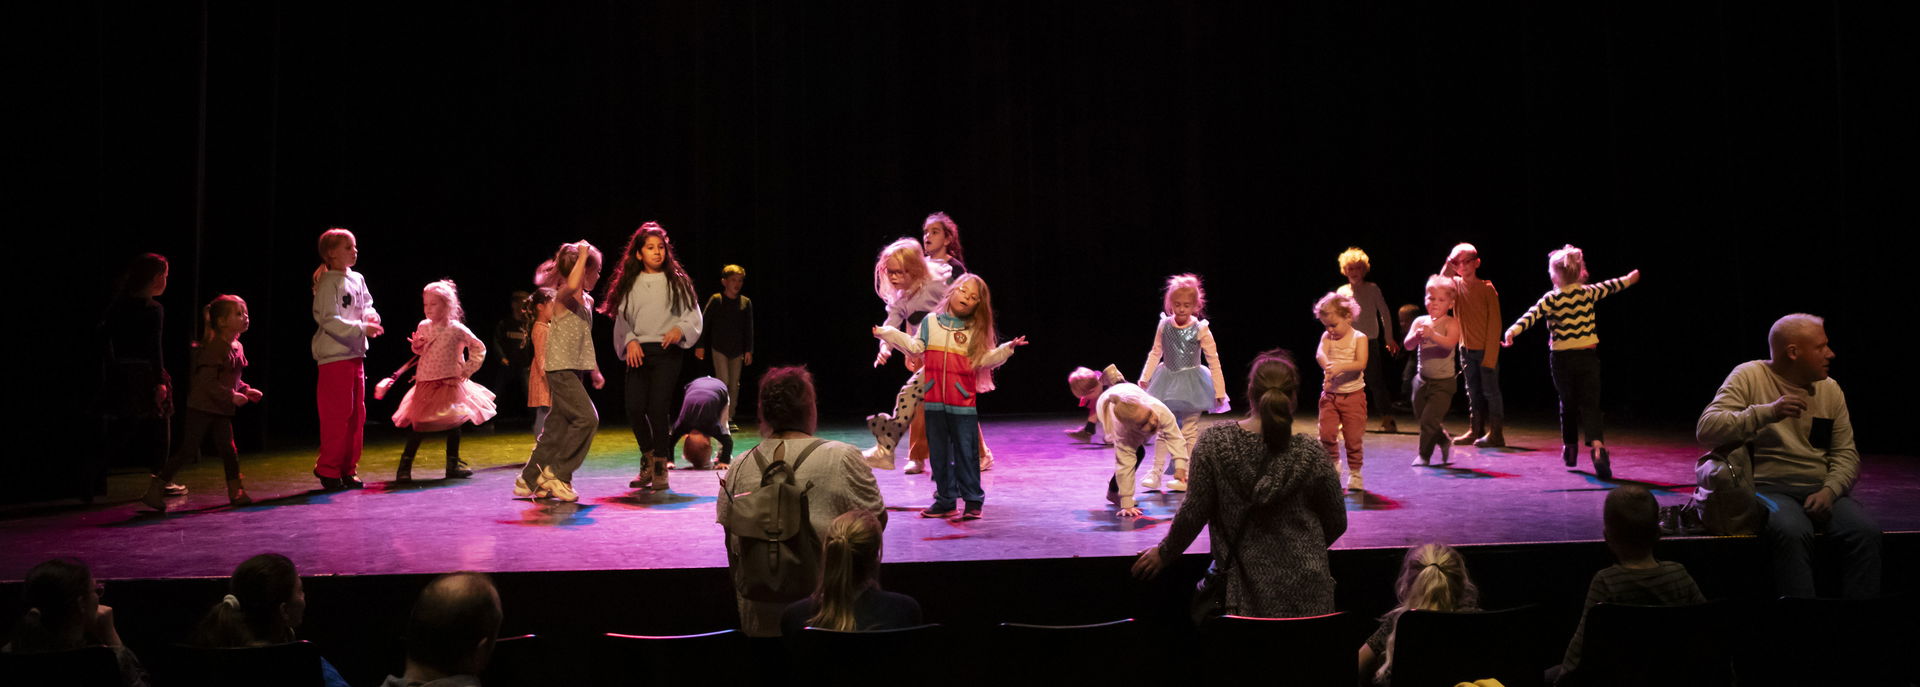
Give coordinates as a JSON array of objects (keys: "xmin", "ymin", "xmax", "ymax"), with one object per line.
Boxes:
[{"xmin": 0, "ymin": 416, "xmax": 1920, "ymax": 580}]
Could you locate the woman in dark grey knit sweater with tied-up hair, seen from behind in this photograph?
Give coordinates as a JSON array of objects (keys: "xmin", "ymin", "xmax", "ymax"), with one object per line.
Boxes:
[{"xmin": 1133, "ymin": 349, "xmax": 1346, "ymax": 618}]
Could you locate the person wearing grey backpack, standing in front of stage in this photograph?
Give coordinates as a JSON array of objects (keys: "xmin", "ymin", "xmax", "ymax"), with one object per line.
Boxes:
[{"xmin": 714, "ymin": 367, "xmax": 887, "ymax": 637}]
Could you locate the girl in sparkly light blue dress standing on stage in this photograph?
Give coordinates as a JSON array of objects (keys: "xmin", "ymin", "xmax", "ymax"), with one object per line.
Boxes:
[{"xmin": 1140, "ymin": 274, "xmax": 1229, "ymax": 491}]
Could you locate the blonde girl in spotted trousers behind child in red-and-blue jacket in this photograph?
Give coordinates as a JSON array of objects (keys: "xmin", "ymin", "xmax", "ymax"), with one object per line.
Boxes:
[{"xmin": 860, "ymin": 238, "xmax": 947, "ymax": 474}]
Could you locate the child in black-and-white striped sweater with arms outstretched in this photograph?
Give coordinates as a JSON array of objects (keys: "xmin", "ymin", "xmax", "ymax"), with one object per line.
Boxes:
[{"xmin": 1500, "ymin": 244, "xmax": 1640, "ymax": 480}]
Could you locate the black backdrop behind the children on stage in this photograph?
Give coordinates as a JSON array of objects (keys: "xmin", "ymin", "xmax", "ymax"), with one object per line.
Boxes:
[{"xmin": 15, "ymin": 0, "xmax": 1920, "ymax": 479}]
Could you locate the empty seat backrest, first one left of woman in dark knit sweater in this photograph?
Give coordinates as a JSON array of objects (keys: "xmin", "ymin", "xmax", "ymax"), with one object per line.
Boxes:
[{"xmin": 981, "ymin": 618, "xmax": 1140, "ymax": 685}]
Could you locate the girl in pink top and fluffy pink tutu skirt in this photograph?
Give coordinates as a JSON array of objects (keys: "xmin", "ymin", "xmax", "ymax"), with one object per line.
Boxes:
[{"xmin": 394, "ymin": 280, "xmax": 495, "ymax": 482}]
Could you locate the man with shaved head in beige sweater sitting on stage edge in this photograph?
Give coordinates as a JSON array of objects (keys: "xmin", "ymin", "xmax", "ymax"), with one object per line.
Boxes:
[{"xmin": 1693, "ymin": 315, "xmax": 1880, "ymax": 599}]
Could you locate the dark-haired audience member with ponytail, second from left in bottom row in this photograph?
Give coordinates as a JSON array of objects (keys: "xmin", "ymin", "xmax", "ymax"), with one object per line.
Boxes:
[{"xmin": 192, "ymin": 553, "xmax": 348, "ymax": 687}]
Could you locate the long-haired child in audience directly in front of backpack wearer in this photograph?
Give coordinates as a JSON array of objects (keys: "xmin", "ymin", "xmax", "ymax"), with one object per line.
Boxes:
[{"xmin": 780, "ymin": 510, "xmax": 920, "ymax": 637}]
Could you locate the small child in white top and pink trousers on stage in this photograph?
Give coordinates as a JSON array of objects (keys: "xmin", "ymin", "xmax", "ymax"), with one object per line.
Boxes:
[{"xmin": 1313, "ymin": 292, "xmax": 1369, "ymax": 491}]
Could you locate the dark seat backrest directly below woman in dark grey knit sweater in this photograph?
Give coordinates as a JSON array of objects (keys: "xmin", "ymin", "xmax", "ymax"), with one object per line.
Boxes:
[{"xmin": 1200, "ymin": 612, "xmax": 1357, "ymax": 685}]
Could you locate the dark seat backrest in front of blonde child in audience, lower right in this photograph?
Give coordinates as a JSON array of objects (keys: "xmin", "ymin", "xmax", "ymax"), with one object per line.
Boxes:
[{"xmin": 1392, "ymin": 604, "xmax": 1542, "ymax": 687}]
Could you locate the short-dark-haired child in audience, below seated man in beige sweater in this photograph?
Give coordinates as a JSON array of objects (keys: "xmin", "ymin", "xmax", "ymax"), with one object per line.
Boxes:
[{"xmin": 1548, "ymin": 484, "xmax": 1707, "ymax": 681}]
